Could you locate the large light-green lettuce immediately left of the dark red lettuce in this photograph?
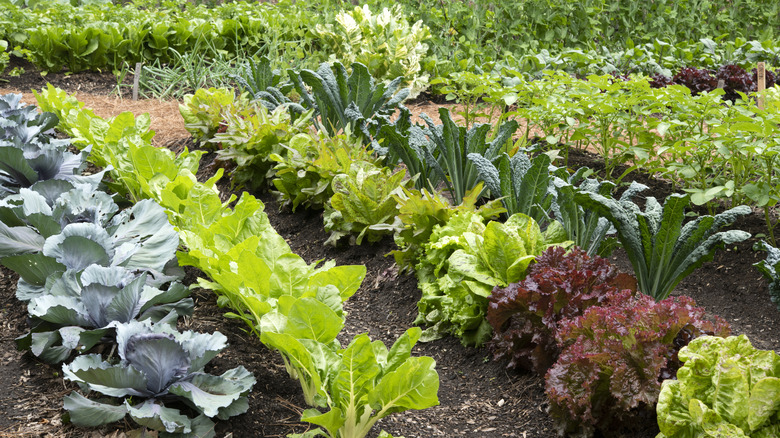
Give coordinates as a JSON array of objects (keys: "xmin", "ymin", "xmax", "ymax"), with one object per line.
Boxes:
[{"xmin": 415, "ymin": 210, "xmax": 565, "ymax": 345}]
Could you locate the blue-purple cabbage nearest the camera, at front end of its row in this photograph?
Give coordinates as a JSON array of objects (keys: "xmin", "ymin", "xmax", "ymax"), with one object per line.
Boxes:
[{"xmin": 62, "ymin": 321, "xmax": 255, "ymax": 436}]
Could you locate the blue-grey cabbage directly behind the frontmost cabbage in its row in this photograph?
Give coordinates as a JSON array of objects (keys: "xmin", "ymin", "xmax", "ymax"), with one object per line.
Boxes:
[{"xmin": 16, "ymin": 265, "xmax": 193, "ymax": 363}]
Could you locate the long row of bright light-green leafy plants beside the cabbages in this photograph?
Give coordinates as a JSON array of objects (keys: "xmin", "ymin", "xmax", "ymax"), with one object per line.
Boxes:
[{"xmin": 37, "ymin": 88, "xmax": 438, "ymax": 438}]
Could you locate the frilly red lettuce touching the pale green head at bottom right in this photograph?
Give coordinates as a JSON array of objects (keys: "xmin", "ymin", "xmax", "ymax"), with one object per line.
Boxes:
[{"xmin": 545, "ymin": 291, "xmax": 730, "ymax": 437}]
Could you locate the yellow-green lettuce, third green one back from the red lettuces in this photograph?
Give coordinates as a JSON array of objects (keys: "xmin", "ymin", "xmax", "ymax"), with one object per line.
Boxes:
[{"xmin": 323, "ymin": 161, "xmax": 408, "ymax": 245}]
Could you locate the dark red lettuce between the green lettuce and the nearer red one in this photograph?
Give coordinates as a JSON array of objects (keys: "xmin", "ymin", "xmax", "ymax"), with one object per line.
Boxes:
[{"xmin": 487, "ymin": 246, "xmax": 636, "ymax": 374}]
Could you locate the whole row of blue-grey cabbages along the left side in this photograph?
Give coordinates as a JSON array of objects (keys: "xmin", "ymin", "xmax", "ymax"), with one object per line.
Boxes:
[{"xmin": 0, "ymin": 94, "xmax": 255, "ymax": 436}]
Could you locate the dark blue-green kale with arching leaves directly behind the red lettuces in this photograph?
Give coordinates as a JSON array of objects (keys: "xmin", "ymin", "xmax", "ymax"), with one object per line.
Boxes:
[{"xmin": 574, "ymin": 182, "xmax": 751, "ymax": 301}]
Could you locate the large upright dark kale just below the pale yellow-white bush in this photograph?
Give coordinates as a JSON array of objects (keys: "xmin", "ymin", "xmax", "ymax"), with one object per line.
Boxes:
[{"xmin": 288, "ymin": 62, "xmax": 409, "ymax": 143}]
